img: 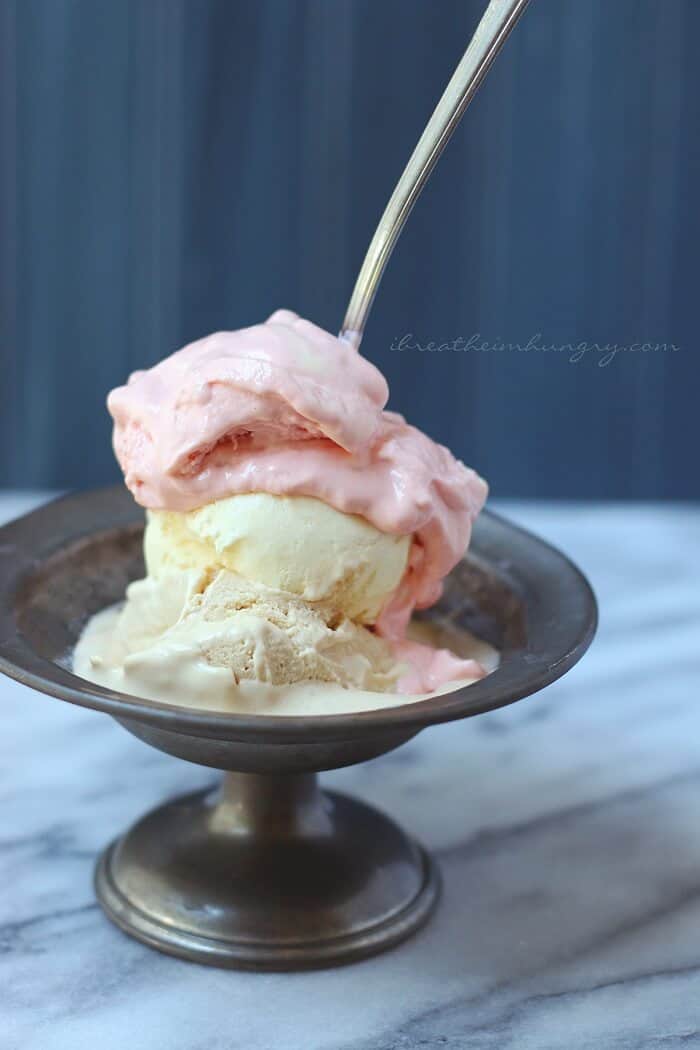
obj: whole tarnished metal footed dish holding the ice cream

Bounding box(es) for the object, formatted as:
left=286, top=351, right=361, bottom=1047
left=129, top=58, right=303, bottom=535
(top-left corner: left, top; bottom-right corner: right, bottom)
left=0, top=486, right=596, bottom=970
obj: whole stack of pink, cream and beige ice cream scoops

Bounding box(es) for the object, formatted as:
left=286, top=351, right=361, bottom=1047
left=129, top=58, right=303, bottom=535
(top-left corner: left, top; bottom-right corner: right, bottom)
left=75, top=310, right=488, bottom=713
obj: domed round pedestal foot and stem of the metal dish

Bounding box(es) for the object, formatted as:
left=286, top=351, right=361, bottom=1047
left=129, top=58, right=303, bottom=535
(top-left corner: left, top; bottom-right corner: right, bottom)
left=96, top=773, right=440, bottom=970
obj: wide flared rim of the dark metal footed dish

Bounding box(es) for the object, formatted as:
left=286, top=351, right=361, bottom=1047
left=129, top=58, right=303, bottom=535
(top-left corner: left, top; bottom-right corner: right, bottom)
left=0, top=485, right=597, bottom=744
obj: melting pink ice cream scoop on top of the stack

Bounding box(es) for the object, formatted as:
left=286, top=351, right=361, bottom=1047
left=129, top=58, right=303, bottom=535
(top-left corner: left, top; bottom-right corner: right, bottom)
left=107, top=310, right=488, bottom=689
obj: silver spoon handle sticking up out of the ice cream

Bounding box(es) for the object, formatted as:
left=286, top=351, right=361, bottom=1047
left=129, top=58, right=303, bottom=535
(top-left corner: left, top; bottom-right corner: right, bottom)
left=340, top=0, right=528, bottom=347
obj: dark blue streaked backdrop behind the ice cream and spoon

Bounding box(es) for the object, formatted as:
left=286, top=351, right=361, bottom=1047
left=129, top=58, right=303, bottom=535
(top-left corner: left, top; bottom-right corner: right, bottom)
left=0, top=0, right=700, bottom=498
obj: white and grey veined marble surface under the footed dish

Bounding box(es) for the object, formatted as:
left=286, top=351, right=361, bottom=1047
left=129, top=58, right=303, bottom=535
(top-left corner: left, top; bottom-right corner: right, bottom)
left=0, top=495, right=700, bottom=1050
